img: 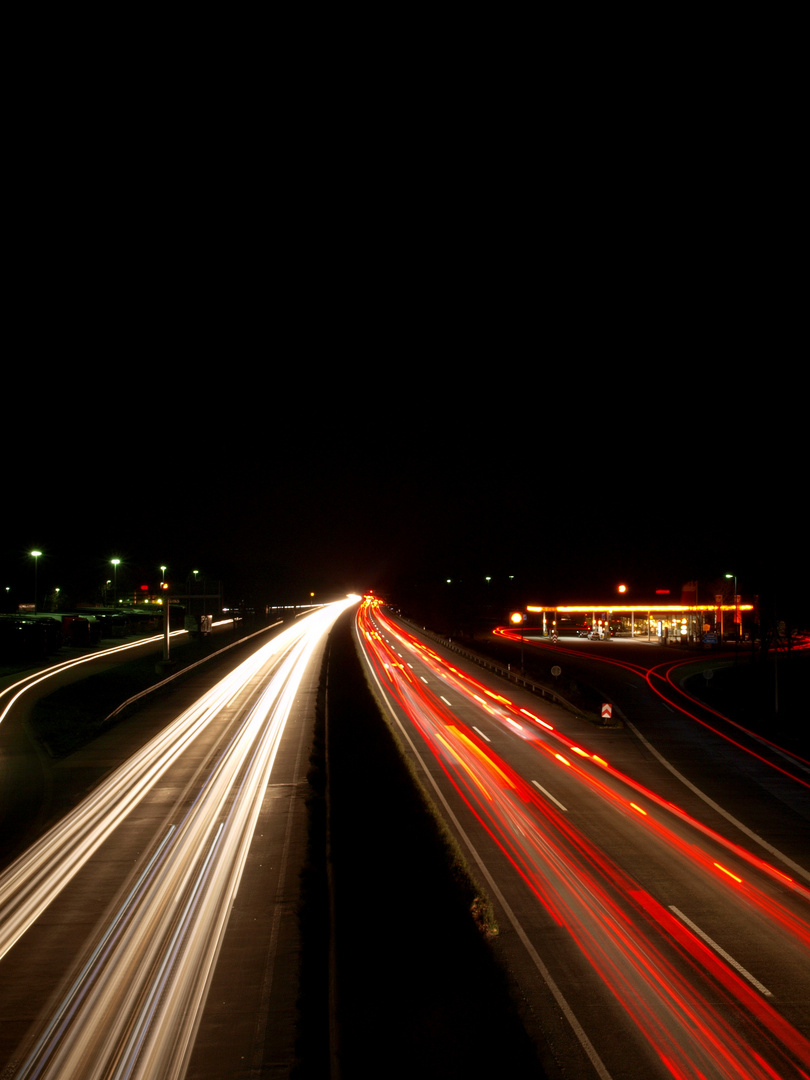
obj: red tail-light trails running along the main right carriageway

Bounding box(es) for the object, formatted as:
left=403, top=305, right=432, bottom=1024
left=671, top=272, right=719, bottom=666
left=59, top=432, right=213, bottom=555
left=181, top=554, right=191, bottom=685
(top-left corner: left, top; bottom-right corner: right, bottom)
left=357, top=603, right=810, bottom=1080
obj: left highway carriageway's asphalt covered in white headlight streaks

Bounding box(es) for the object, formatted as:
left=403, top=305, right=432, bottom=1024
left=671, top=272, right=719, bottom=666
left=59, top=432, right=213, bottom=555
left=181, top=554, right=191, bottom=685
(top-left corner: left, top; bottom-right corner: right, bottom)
left=0, top=599, right=354, bottom=1080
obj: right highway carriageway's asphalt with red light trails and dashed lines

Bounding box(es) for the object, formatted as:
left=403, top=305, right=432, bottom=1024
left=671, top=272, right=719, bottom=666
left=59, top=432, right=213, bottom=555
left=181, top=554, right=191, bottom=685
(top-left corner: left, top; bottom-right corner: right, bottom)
left=356, top=602, right=810, bottom=1080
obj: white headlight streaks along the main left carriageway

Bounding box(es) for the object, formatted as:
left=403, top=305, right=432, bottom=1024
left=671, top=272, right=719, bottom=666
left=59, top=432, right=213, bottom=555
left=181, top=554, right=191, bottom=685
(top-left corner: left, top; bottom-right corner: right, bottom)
left=0, top=600, right=353, bottom=1080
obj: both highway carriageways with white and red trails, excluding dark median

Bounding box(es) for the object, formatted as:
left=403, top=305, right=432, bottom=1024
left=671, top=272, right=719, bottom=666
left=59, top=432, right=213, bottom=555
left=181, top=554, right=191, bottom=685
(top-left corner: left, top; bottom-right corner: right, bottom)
left=6, top=602, right=810, bottom=1080
